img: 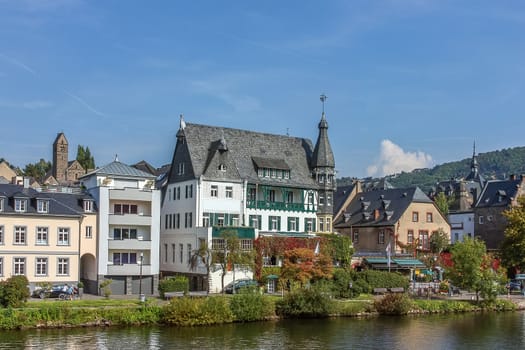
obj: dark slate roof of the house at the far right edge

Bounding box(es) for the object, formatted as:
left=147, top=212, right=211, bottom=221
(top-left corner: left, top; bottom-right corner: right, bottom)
left=476, top=178, right=523, bottom=208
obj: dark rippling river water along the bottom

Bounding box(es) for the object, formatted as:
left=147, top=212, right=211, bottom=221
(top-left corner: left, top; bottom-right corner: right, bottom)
left=0, top=312, right=525, bottom=350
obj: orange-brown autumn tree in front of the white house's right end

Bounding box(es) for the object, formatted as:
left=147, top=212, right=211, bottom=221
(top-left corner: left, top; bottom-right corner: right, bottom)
left=281, top=248, right=332, bottom=286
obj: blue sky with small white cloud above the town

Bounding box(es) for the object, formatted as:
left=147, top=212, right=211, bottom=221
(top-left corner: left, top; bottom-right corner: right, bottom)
left=0, top=0, right=525, bottom=177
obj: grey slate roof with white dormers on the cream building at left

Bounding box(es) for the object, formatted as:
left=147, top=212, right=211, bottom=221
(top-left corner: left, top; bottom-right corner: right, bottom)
left=0, top=184, right=95, bottom=217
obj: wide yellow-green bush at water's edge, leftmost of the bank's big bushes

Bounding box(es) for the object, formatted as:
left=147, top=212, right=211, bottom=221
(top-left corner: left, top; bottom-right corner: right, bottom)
left=163, top=297, right=233, bottom=326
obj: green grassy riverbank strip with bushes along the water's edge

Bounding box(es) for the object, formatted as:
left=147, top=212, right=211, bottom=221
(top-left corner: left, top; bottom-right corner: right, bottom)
left=0, top=291, right=516, bottom=329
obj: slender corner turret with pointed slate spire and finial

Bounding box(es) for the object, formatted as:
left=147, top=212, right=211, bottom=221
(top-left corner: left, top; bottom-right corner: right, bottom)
left=311, top=94, right=336, bottom=232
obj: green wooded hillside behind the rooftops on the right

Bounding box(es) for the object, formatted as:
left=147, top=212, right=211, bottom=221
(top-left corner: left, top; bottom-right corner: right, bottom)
left=337, top=147, right=525, bottom=192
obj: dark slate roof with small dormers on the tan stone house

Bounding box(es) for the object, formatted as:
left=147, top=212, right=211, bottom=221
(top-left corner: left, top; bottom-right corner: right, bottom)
left=334, top=187, right=433, bottom=228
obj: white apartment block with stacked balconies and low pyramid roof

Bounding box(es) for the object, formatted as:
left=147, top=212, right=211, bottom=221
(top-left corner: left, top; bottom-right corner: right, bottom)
left=80, top=160, right=161, bottom=294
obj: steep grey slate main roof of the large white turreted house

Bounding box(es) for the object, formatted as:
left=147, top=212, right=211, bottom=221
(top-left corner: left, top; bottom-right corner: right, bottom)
left=174, top=123, right=318, bottom=188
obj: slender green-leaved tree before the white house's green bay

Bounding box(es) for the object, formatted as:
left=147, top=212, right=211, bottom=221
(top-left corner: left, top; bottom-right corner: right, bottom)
left=213, top=229, right=255, bottom=293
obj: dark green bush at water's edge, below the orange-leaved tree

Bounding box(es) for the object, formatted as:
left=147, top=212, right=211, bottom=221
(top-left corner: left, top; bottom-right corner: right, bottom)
left=275, top=288, right=334, bottom=317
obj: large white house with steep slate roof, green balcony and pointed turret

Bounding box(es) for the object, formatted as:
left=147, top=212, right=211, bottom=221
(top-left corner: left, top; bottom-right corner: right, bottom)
left=160, top=109, right=335, bottom=292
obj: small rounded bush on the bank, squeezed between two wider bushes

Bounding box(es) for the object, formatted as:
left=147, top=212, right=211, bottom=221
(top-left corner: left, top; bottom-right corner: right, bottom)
left=230, top=293, right=274, bottom=322
